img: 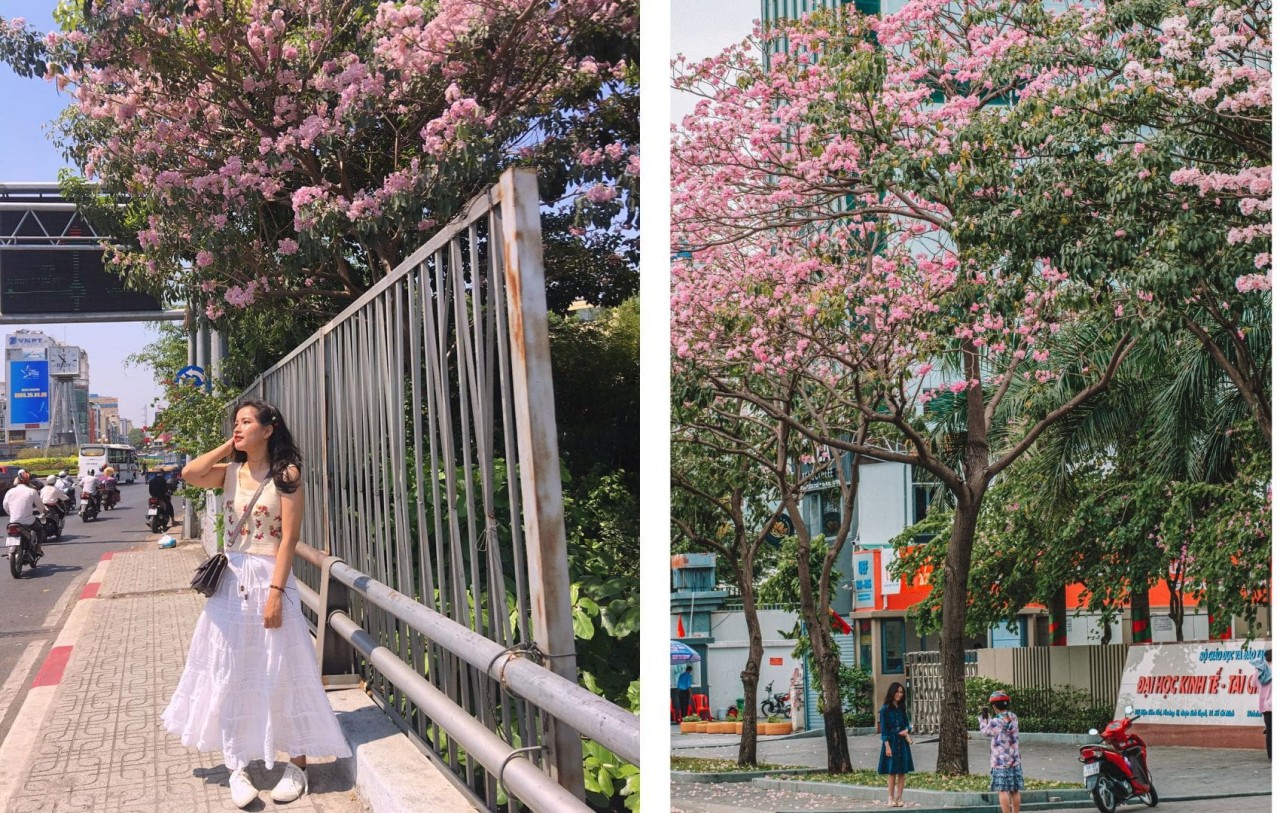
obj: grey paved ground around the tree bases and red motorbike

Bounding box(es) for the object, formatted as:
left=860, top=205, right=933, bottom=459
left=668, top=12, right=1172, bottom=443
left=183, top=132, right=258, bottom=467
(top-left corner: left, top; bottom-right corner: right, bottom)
left=671, top=734, right=1271, bottom=813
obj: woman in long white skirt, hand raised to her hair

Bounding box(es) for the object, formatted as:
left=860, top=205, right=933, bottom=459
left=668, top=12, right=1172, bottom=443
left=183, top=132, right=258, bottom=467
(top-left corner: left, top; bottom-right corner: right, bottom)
left=163, top=401, right=351, bottom=808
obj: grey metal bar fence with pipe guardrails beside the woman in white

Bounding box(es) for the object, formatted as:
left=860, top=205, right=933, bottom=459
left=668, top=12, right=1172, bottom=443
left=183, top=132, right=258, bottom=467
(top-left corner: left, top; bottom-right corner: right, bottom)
left=224, top=170, right=640, bottom=810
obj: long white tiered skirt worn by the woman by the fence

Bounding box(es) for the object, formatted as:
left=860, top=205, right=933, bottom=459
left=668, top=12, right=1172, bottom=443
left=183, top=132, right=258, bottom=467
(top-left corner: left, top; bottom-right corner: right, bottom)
left=161, top=553, right=351, bottom=771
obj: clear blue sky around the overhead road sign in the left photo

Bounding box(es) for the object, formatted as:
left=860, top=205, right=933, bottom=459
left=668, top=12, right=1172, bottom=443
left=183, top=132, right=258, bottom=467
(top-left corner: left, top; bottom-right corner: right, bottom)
left=0, top=0, right=172, bottom=425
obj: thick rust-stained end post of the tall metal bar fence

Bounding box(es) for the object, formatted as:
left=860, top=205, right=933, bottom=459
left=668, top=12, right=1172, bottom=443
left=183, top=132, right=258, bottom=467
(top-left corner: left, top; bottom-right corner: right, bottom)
left=498, top=169, right=585, bottom=799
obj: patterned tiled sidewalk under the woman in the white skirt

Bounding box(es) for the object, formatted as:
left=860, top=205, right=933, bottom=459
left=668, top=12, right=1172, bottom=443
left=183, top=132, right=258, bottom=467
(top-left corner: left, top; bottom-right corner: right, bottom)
left=8, top=544, right=365, bottom=813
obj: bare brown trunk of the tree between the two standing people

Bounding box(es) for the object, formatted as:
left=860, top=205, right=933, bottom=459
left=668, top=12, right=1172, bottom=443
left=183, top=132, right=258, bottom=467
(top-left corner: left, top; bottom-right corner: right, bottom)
left=937, top=499, right=980, bottom=776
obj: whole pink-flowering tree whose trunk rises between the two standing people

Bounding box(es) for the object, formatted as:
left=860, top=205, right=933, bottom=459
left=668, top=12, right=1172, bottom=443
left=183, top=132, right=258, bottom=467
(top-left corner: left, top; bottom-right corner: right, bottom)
left=672, top=0, right=1268, bottom=772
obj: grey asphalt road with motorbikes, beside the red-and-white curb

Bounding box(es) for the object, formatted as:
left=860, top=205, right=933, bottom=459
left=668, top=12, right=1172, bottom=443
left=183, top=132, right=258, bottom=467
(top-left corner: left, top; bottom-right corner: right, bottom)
left=0, top=483, right=183, bottom=740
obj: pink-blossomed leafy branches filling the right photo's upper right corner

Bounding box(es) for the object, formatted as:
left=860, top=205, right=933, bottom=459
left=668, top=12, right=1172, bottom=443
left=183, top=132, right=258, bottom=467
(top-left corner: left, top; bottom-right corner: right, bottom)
left=972, top=0, right=1271, bottom=438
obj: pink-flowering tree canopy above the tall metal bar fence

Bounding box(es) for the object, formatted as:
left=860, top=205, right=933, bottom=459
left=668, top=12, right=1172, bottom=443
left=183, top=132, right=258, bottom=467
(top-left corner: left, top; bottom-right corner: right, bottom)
left=0, top=0, right=639, bottom=320
